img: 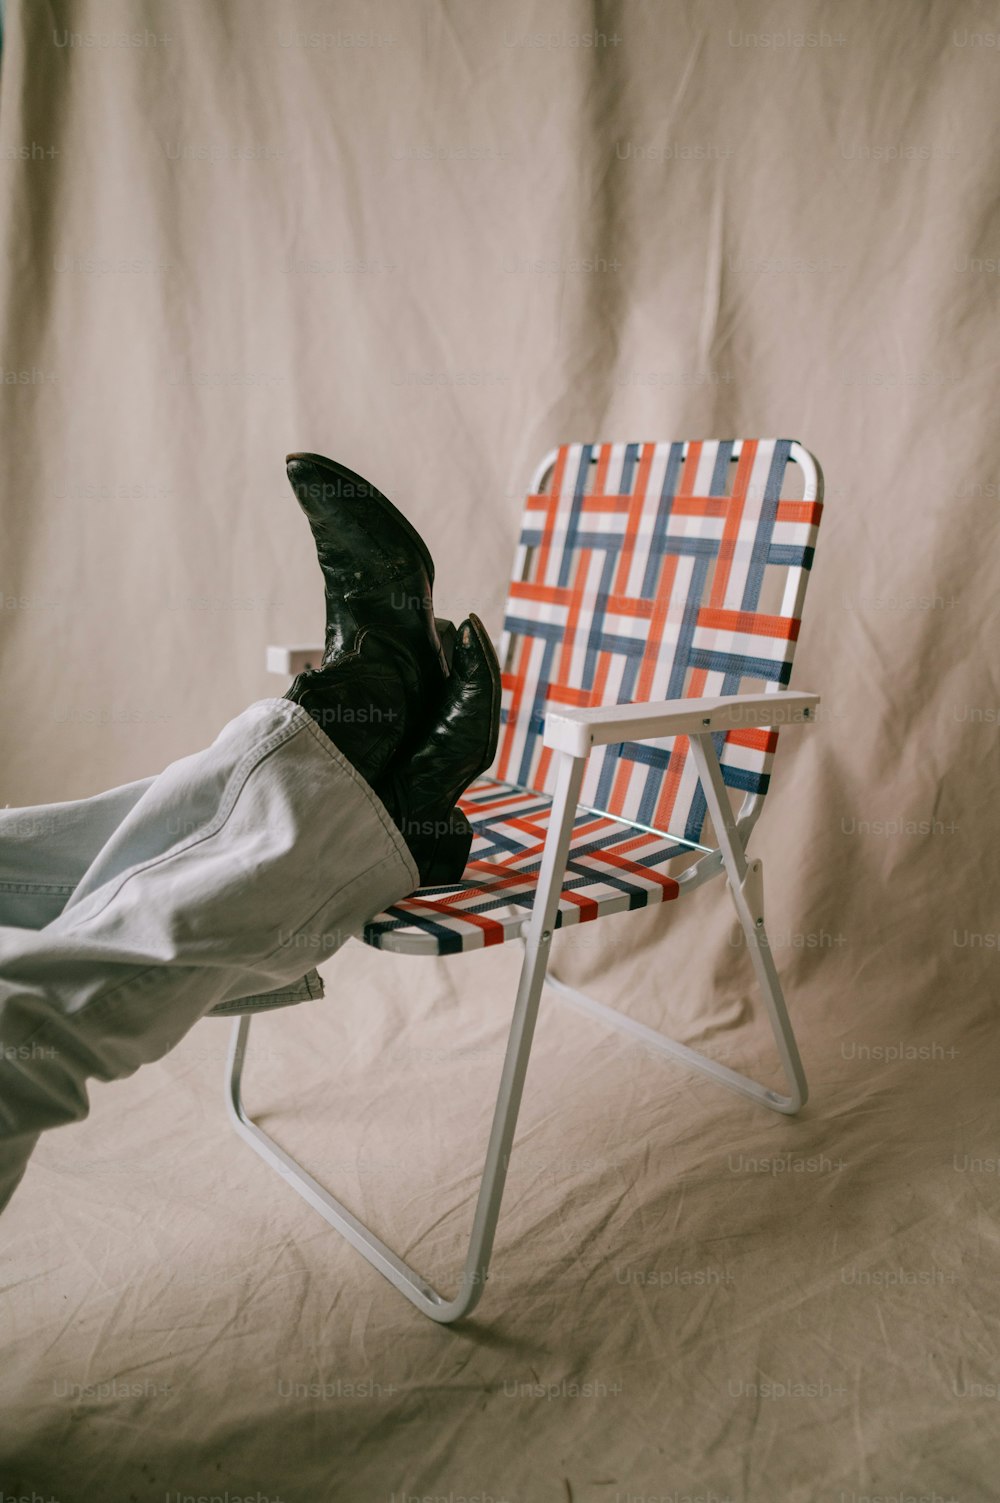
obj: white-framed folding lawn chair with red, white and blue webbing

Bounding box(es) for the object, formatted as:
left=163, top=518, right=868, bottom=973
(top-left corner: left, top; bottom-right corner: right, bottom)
left=222, top=439, right=823, bottom=1323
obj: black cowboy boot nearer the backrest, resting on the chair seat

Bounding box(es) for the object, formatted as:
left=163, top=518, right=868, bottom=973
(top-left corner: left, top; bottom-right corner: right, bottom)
left=373, top=615, right=501, bottom=887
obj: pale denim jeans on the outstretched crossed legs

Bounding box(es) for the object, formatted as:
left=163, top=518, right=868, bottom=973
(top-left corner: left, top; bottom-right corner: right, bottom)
left=0, top=699, right=420, bottom=1208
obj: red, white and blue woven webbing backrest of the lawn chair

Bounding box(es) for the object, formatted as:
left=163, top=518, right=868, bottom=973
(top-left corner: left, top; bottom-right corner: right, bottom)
left=495, top=439, right=823, bottom=842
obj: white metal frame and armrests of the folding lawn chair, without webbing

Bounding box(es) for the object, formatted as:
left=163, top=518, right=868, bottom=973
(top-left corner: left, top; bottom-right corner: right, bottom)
left=227, top=443, right=823, bottom=1324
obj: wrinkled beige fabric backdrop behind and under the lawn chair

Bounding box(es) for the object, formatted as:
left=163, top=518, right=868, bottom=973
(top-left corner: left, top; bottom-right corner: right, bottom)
left=0, top=0, right=1000, bottom=1503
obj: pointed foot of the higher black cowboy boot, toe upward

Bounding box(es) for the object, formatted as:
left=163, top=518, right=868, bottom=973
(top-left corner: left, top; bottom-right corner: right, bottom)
left=286, top=454, right=454, bottom=745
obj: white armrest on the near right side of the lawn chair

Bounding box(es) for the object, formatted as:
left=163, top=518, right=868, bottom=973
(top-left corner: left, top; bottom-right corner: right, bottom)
left=543, top=691, right=820, bottom=756
